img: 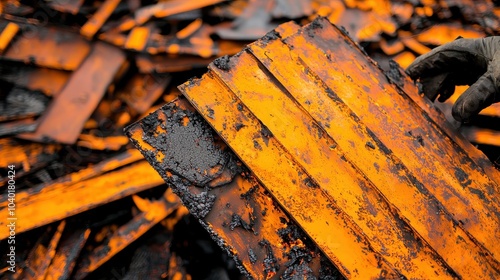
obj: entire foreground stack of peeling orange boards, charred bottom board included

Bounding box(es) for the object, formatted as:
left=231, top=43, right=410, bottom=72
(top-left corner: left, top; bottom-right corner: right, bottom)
left=128, top=18, right=500, bottom=279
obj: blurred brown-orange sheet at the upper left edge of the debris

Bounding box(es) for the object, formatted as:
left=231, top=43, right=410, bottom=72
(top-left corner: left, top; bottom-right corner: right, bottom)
left=0, top=24, right=91, bottom=71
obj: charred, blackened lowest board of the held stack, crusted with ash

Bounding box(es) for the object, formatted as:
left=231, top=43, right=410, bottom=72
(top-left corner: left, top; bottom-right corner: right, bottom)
left=126, top=99, right=344, bottom=279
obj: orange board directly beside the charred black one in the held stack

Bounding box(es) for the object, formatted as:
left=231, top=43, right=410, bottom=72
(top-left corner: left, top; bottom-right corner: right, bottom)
left=180, top=72, right=398, bottom=279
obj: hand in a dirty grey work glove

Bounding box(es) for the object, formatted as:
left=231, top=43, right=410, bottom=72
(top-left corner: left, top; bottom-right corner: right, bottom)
left=406, top=36, right=500, bottom=121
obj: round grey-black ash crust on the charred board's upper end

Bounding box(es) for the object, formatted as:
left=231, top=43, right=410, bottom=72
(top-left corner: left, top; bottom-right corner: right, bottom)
left=141, top=104, right=229, bottom=186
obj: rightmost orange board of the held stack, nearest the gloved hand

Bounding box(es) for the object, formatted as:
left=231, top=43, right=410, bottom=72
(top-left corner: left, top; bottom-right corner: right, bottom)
left=285, top=18, right=500, bottom=260
